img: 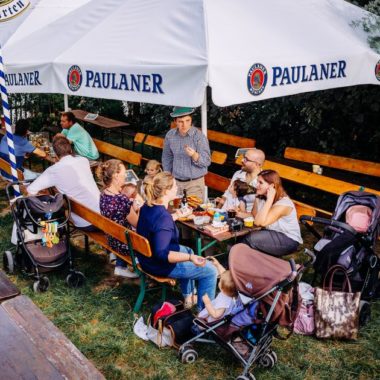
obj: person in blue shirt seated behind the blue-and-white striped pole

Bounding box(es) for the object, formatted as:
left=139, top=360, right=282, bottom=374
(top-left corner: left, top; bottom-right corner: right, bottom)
left=0, top=119, right=46, bottom=180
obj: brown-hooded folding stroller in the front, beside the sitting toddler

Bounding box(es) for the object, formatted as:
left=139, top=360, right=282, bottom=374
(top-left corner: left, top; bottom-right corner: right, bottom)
left=179, top=244, right=314, bottom=380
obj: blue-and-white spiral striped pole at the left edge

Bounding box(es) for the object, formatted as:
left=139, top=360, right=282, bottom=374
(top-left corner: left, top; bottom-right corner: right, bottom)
left=0, top=46, right=20, bottom=197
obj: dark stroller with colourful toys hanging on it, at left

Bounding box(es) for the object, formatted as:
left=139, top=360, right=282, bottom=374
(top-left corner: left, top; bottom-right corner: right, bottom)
left=3, top=181, right=85, bottom=292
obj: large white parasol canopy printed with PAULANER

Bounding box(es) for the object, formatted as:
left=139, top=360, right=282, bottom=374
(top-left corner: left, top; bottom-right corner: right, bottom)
left=4, top=0, right=380, bottom=106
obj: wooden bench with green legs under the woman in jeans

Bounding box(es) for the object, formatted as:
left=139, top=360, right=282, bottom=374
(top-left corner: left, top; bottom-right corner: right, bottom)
left=70, top=199, right=176, bottom=313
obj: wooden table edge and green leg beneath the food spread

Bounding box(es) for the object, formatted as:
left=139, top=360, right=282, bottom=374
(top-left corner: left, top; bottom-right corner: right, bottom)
left=177, top=220, right=257, bottom=256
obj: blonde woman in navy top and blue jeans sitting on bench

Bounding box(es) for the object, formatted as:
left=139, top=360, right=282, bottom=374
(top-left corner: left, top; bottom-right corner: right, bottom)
left=137, top=172, right=217, bottom=310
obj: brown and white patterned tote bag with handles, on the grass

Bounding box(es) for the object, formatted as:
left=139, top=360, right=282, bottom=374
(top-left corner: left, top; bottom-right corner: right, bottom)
left=314, top=265, right=360, bottom=339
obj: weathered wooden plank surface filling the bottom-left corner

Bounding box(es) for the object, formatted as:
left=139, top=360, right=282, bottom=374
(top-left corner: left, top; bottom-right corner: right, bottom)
left=0, top=296, right=105, bottom=380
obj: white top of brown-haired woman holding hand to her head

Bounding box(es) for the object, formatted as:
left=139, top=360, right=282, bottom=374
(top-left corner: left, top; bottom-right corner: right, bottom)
left=257, top=197, right=302, bottom=244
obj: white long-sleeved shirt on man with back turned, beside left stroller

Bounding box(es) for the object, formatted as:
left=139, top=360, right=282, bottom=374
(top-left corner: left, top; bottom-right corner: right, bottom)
left=27, top=155, right=100, bottom=227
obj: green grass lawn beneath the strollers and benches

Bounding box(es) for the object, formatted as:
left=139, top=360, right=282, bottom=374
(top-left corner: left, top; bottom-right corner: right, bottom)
left=0, top=192, right=380, bottom=380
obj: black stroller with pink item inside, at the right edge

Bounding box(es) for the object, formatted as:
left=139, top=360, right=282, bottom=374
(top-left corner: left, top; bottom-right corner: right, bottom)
left=300, top=191, right=380, bottom=325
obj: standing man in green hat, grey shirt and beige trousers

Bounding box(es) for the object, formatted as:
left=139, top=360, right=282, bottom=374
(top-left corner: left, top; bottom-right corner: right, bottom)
left=162, top=107, right=211, bottom=200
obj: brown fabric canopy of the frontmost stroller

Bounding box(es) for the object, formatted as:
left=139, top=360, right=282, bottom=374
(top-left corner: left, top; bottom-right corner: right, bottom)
left=229, top=244, right=292, bottom=298
